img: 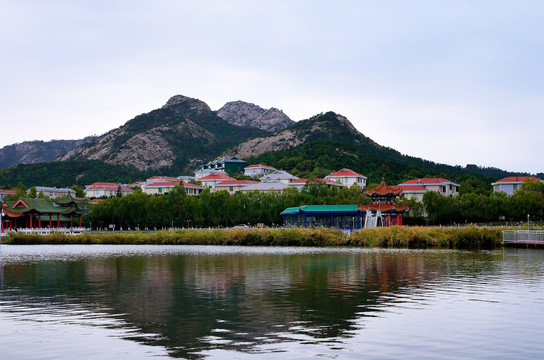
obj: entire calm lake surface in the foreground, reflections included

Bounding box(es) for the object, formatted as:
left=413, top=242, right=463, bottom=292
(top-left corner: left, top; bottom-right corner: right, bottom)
left=0, top=245, right=544, bottom=360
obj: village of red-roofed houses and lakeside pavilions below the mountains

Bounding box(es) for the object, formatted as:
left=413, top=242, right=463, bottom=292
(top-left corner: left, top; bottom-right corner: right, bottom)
left=0, top=157, right=544, bottom=235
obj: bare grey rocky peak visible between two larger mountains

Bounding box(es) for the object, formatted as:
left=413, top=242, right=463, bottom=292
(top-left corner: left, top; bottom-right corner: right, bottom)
left=216, top=101, right=295, bottom=132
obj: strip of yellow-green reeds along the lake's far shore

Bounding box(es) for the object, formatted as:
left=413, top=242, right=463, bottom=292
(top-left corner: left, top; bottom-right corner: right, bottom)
left=0, top=226, right=502, bottom=249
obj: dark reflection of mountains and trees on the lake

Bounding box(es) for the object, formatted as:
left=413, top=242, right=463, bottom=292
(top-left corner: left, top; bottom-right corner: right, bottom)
left=2, top=250, right=504, bottom=357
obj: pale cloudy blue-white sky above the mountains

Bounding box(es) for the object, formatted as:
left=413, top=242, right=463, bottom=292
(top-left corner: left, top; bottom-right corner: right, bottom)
left=0, top=0, right=544, bottom=174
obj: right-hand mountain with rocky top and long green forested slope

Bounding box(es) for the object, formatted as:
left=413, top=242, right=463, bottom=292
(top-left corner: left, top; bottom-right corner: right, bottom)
left=223, top=112, right=511, bottom=182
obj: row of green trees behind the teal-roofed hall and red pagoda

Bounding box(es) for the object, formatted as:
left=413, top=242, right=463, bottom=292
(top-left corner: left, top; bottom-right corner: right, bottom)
left=87, top=181, right=544, bottom=228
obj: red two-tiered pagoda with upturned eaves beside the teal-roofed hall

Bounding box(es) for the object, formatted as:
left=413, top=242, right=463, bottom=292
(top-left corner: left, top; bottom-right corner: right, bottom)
left=359, top=178, right=408, bottom=227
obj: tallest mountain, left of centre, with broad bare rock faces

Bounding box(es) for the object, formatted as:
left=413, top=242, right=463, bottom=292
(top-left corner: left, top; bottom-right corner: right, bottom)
left=60, top=95, right=263, bottom=172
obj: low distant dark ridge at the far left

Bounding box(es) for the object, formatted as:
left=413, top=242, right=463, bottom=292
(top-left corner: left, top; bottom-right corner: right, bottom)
left=0, top=136, right=95, bottom=169
